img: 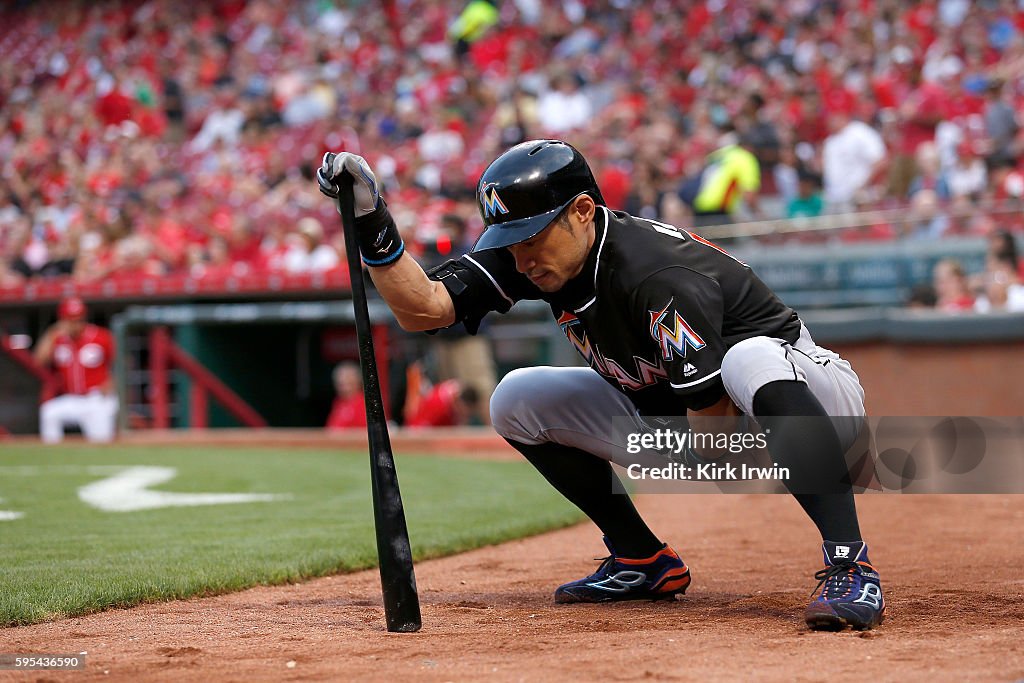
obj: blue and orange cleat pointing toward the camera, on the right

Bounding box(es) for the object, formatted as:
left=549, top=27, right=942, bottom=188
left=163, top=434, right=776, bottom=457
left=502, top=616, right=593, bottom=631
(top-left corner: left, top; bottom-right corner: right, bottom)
left=804, top=541, right=886, bottom=631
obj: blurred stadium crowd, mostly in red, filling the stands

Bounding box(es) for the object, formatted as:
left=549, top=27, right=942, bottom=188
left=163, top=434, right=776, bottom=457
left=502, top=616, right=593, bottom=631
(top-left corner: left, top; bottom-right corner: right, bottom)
left=0, top=0, right=1024, bottom=307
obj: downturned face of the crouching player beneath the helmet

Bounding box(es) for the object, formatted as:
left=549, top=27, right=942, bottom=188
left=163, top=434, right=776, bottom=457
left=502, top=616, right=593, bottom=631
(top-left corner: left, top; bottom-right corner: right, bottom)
left=508, top=195, right=596, bottom=292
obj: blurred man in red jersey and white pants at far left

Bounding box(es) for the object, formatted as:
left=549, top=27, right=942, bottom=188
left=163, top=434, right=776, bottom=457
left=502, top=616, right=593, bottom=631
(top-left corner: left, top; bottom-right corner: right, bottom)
left=34, top=297, right=118, bottom=443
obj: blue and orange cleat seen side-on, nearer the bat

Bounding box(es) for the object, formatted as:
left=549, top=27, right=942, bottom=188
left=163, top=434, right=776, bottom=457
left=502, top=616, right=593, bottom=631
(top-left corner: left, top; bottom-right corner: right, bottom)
left=555, top=539, right=690, bottom=603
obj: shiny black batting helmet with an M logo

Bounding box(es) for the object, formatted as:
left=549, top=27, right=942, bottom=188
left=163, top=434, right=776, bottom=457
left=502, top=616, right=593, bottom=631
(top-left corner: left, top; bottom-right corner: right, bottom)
left=473, top=140, right=604, bottom=251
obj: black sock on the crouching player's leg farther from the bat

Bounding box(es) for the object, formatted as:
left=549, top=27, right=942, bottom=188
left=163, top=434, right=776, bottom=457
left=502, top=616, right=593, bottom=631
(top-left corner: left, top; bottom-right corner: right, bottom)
left=754, top=380, right=861, bottom=541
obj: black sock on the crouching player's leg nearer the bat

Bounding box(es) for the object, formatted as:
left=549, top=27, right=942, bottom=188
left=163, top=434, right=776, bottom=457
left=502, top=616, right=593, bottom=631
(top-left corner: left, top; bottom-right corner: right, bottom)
left=505, top=439, right=664, bottom=558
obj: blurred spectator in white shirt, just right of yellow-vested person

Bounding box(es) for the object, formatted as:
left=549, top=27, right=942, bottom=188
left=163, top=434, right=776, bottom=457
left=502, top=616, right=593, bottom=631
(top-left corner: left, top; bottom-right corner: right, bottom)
left=821, top=112, right=886, bottom=213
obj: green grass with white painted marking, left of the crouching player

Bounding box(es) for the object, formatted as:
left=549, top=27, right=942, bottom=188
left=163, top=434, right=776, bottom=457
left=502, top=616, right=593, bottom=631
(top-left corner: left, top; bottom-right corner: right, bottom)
left=0, top=445, right=581, bottom=626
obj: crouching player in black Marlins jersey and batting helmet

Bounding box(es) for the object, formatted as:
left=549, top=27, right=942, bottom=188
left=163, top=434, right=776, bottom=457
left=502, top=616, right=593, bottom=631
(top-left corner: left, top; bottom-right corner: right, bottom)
left=317, top=140, right=885, bottom=630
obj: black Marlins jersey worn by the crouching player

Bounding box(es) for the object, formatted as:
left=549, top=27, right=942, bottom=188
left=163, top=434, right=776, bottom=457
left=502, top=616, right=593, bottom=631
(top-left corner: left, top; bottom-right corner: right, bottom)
left=431, top=207, right=800, bottom=415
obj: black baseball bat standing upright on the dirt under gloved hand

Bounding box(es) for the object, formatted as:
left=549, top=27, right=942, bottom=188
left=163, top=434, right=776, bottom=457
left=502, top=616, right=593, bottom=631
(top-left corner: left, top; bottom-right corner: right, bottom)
left=338, top=171, right=421, bottom=633
